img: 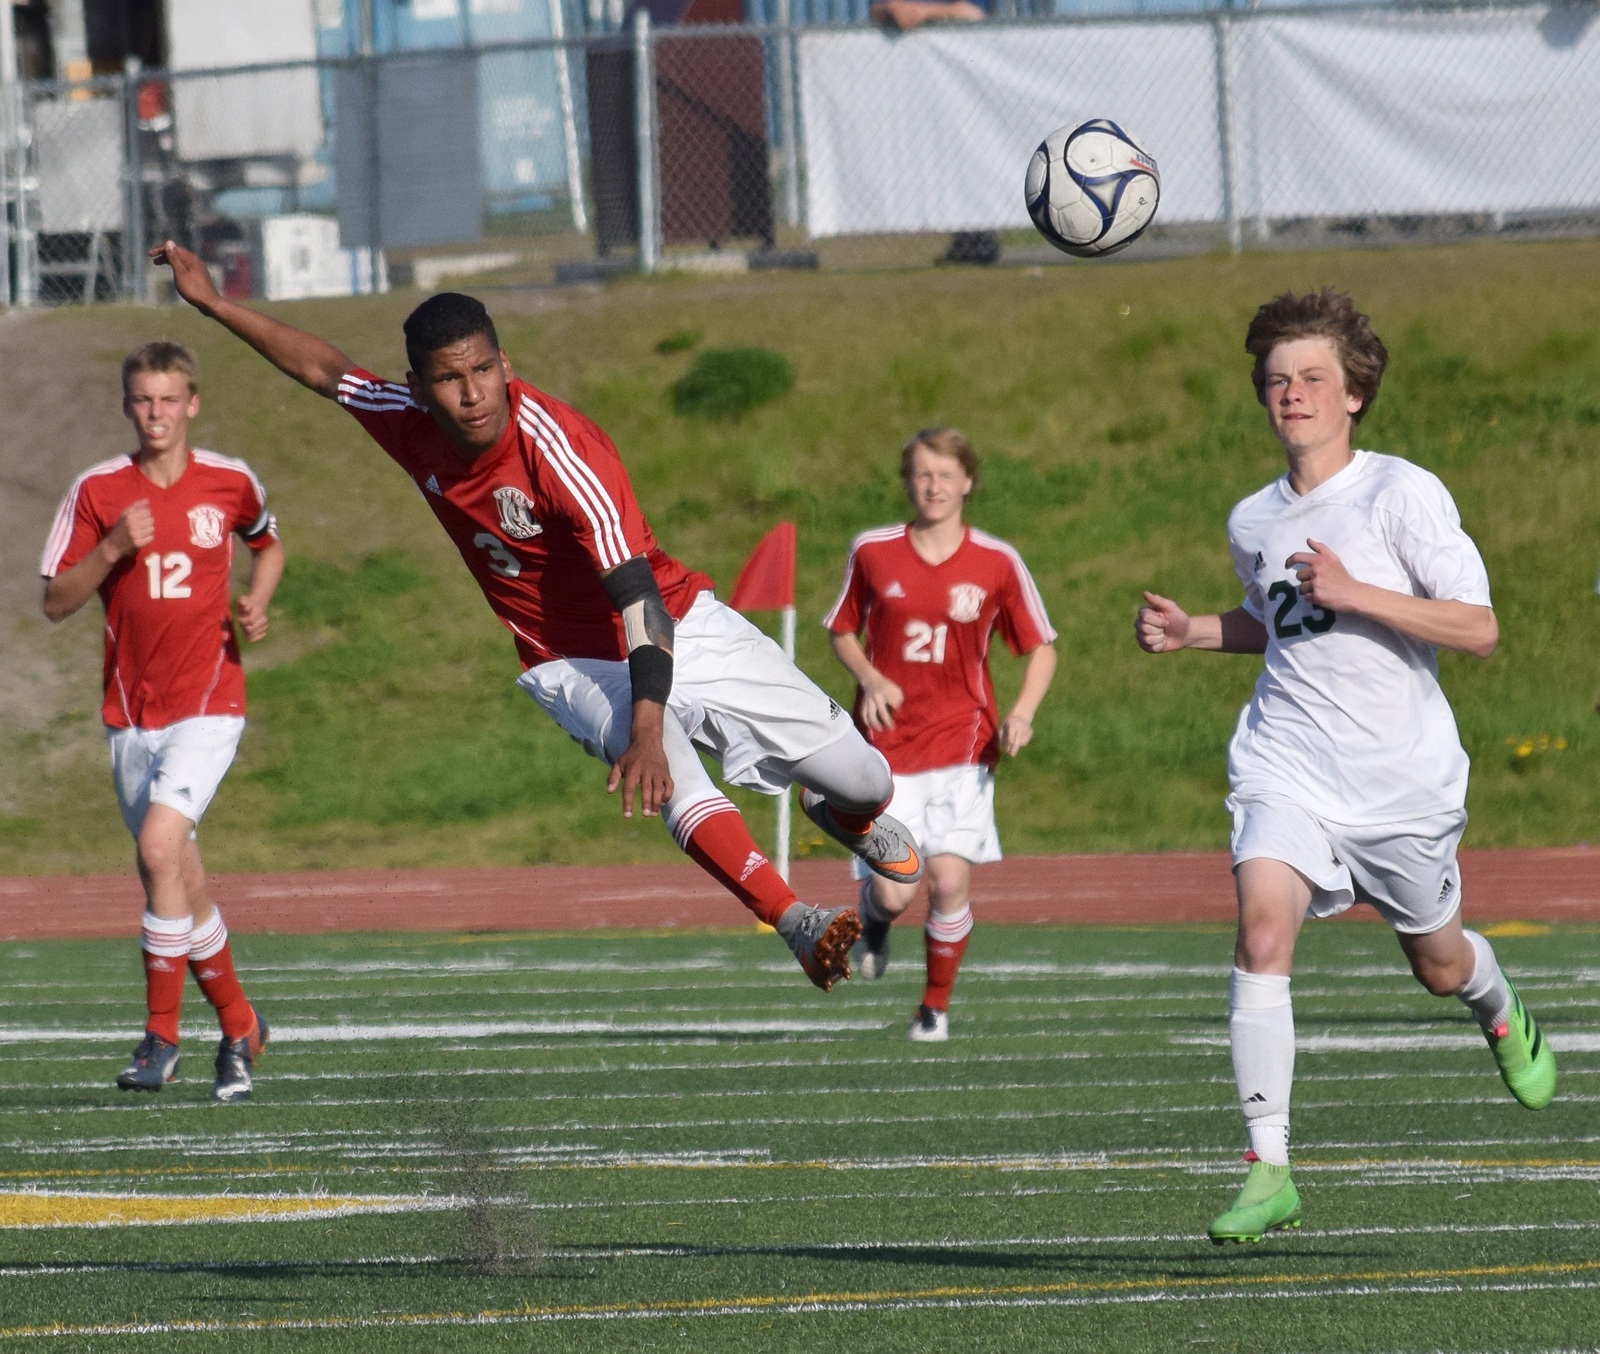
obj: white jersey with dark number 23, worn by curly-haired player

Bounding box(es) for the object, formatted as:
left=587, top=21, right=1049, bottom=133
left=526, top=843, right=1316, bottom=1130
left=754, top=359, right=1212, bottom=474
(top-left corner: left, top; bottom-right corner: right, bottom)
left=1227, top=451, right=1490, bottom=826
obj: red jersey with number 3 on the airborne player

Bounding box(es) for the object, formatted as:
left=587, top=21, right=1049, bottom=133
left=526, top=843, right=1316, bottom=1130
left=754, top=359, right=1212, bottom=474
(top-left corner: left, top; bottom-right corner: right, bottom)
left=339, top=370, right=714, bottom=667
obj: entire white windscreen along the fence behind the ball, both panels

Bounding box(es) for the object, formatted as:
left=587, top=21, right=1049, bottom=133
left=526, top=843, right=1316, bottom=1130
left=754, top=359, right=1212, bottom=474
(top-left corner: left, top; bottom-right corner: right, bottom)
left=800, top=6, right=1600, bottom=237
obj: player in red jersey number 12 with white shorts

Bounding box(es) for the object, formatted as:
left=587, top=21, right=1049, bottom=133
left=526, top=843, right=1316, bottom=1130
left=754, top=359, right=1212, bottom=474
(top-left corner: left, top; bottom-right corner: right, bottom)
left=40, top=343, right=283, bottom=1101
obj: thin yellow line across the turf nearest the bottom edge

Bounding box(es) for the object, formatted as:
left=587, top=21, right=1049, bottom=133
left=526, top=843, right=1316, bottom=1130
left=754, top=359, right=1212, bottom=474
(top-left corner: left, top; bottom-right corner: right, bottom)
left=0, top=1260, right=1600, bottom=1340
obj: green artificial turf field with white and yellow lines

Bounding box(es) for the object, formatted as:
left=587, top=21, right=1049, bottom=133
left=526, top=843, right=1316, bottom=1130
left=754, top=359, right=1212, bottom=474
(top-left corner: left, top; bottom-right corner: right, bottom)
left=0, top=922, right=1600, bottom=1354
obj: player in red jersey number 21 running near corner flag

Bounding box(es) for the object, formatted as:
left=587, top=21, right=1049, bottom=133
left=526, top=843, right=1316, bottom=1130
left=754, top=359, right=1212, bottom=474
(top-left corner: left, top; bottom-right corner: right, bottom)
left=824, top=427, right=1056, bottom=1042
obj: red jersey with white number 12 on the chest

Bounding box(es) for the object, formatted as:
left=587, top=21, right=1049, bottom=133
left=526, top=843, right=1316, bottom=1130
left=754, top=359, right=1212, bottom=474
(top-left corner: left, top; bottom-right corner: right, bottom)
left=38, top=448, right=278, bottom=728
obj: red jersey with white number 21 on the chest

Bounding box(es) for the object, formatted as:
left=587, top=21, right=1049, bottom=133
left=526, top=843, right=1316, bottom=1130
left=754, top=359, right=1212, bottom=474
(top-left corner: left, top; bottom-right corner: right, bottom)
left=822, top=527, right=1056, bottom=776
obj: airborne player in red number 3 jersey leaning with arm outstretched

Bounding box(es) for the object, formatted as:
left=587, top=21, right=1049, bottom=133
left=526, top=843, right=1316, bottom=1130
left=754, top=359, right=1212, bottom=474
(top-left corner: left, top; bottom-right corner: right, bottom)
left=154, top=243, right=922, bottom=991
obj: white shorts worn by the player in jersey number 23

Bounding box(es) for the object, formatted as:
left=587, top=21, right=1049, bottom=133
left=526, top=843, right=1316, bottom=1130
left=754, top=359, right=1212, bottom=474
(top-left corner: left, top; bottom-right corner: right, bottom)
left=1227, top=795, right=1467, bottom=936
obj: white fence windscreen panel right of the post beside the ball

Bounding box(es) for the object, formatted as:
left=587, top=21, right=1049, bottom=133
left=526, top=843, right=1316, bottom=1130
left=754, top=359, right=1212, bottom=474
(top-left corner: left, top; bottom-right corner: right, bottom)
left=1228, top=5, right=1600, bottom=218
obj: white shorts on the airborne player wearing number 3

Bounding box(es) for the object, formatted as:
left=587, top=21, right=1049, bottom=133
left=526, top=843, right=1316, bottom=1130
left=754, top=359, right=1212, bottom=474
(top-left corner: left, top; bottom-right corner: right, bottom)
left=517, top=592, right=853, bottom=802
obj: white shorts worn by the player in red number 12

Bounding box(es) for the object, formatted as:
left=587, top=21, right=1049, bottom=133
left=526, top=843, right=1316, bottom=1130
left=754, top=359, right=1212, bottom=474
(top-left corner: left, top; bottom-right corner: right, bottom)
left=106, top=715, right=245, bottom=837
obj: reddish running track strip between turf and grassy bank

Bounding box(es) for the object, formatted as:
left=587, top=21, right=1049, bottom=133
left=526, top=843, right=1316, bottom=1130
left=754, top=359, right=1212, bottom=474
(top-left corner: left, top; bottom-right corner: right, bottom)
left=0, top=848, right=1600, bottom=939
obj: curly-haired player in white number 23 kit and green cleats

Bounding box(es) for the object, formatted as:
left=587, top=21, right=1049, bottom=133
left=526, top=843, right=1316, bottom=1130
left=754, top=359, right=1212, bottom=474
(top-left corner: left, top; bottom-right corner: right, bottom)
left=1136, top=290, right=1555, bottom=1244
